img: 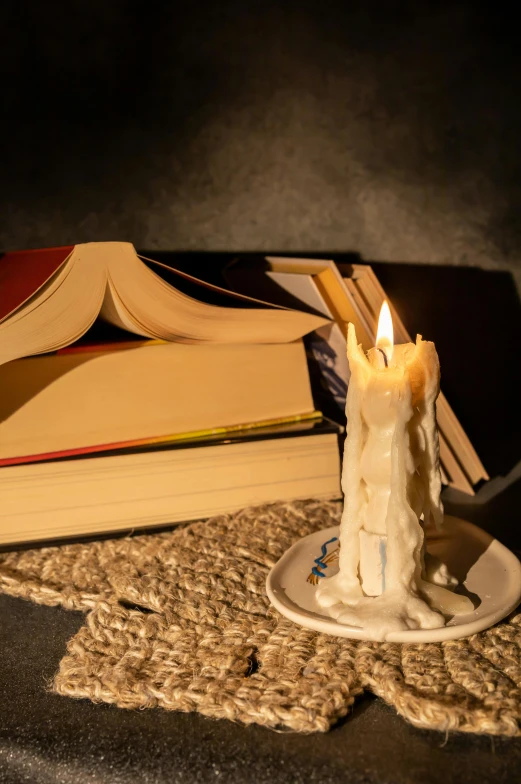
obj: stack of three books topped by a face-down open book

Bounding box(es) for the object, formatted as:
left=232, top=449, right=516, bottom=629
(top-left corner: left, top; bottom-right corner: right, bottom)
left=0, top=243, right=340, bottom=545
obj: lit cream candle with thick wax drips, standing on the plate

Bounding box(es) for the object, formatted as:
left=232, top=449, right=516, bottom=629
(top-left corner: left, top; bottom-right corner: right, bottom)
left=316, top=303, right=473, bottom=640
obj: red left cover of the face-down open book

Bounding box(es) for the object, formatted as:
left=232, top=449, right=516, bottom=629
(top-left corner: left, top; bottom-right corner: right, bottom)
left=0, top=245, right=74, bottom=322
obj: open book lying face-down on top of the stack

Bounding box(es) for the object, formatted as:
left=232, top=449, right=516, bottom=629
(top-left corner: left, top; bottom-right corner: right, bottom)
left=0, top=242, right=326, bottom=364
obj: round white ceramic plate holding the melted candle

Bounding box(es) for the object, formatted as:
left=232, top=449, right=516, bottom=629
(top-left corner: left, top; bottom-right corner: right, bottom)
left=266, top=516, right=521, bottom=642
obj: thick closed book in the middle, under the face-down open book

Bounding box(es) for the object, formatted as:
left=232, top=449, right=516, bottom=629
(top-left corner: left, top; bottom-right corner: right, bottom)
left=0, top=340, right=316, bottom=470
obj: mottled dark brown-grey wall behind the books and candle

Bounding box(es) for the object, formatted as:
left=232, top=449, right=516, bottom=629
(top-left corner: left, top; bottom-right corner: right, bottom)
left=0, top=0, right=521, bottom=282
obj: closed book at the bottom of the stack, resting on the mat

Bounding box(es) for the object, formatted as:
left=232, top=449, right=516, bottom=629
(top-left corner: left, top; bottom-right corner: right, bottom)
left=0, top=420, right=340, bottom=547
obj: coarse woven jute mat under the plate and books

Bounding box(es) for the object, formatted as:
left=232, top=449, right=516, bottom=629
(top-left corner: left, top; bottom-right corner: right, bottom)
left=0, top=501, right=521, bottom=735
